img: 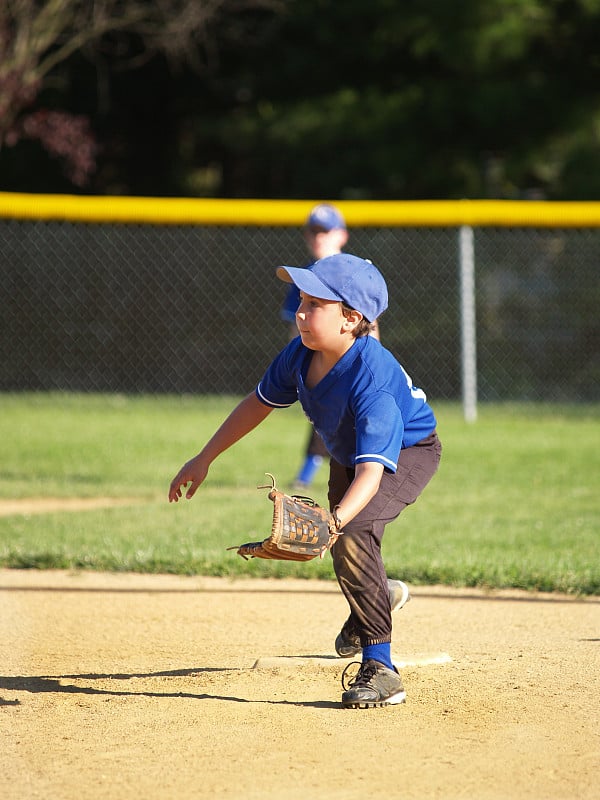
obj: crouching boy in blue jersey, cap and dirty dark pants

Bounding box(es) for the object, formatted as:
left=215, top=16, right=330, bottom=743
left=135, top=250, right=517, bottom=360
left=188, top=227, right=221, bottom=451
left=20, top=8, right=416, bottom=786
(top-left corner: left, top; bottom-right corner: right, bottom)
left=169, top=253, right=441, bottom=708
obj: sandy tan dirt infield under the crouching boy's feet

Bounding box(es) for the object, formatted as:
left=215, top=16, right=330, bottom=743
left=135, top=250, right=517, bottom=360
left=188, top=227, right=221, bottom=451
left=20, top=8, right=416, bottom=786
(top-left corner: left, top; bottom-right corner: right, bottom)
left=0, top=570, right=600, bottom=800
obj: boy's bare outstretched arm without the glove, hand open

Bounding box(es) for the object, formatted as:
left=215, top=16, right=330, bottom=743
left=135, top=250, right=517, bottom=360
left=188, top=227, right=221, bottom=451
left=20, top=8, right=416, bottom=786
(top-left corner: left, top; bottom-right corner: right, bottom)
left=169, top=392, right=273, bottom=503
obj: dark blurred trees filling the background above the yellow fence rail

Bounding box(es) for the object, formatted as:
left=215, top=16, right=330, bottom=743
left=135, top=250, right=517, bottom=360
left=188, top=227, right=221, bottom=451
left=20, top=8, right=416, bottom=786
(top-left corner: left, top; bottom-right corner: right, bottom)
left=0, top=0, right=600, bottom=199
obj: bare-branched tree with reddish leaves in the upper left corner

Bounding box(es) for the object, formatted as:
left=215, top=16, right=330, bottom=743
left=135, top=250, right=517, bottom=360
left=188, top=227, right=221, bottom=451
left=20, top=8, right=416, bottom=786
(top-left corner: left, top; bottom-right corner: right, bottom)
left=0, top=0, right=279, bottom=186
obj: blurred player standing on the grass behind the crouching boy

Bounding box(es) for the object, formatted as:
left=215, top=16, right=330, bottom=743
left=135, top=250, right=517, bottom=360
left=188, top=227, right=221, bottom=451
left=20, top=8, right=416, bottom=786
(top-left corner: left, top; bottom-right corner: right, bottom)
left=281, top=203, right=379, bottom=492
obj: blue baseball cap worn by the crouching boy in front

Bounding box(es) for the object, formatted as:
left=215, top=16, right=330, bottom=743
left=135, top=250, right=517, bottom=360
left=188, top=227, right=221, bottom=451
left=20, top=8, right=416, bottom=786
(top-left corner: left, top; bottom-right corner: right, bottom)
left=276, top=253, right=388, bottom=322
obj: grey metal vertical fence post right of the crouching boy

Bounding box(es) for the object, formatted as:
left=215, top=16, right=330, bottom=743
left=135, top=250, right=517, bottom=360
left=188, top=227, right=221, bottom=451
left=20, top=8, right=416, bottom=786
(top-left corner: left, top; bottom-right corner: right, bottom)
left=458, top=225, right=477, bottom=422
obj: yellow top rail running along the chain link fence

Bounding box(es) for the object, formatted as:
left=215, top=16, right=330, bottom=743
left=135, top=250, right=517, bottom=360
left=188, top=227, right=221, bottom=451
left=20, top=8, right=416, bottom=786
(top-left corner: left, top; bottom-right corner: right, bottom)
left=0, top=192, right=600, bottom=228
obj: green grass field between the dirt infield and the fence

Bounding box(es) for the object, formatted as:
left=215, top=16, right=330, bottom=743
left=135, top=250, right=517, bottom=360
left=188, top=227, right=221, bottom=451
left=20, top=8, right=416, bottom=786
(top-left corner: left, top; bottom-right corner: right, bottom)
left=0, top=393, right=600, bottom=594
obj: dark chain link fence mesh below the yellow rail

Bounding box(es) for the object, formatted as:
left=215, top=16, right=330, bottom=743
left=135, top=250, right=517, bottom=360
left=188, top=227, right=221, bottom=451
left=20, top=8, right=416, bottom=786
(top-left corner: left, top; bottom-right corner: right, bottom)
left=0, top=212, right=600, bottom=402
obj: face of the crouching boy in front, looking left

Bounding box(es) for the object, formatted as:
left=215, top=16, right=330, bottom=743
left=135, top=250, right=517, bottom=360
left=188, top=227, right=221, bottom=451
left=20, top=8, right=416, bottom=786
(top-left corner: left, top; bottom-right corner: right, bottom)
left=296, top=292, right=361, bottom=351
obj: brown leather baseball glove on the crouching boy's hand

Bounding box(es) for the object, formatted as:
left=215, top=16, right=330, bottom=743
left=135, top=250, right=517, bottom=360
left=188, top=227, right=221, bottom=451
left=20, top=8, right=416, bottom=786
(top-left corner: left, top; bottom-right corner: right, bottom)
left=227, top=472, right=340, bottom=561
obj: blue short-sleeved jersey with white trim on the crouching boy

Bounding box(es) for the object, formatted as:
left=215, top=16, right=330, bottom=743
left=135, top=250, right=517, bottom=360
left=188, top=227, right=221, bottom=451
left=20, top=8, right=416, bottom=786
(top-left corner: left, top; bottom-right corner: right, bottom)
left=256, top=336, right=436, bottom=472
